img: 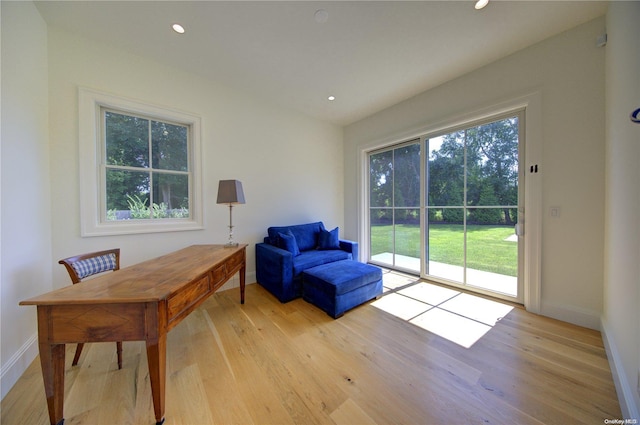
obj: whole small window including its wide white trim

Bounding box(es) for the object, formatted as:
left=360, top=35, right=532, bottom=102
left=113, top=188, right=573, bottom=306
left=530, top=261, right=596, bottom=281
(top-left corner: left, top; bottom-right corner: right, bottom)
left=80, top=89, right=202, bottom=236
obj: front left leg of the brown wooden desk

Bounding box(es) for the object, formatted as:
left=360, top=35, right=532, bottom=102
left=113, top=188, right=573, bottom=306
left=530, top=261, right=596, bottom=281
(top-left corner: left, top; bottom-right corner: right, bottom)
left=38, top=306, right=65, bottom=425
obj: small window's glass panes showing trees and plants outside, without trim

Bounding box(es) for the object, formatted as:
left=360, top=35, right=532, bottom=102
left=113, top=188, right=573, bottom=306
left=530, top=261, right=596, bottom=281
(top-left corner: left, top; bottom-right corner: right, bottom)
left=103, top=109, right=190, bottom=221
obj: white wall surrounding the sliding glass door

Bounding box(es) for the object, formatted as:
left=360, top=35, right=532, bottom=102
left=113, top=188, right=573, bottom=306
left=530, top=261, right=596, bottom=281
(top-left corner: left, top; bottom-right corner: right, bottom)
left=345, top=17, right=605, bottom=328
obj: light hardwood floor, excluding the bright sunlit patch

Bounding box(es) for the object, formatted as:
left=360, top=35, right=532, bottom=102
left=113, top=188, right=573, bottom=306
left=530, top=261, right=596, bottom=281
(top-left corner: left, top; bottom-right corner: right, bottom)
left=1, top=272, right=621, bottom=425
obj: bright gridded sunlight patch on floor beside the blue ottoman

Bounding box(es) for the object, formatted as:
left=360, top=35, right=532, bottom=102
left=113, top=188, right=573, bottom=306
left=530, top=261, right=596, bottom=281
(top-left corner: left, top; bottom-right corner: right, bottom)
left=371, top=272, right=513, bottom=348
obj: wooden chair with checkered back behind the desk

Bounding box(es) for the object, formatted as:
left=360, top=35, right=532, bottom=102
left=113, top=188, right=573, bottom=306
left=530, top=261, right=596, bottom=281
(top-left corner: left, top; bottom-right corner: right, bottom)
left=58, top=248, right=122, bottom=369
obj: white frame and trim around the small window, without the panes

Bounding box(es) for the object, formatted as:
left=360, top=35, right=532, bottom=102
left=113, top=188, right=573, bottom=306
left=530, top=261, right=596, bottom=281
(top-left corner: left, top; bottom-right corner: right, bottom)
left=78, top=87, right=204, bottom=237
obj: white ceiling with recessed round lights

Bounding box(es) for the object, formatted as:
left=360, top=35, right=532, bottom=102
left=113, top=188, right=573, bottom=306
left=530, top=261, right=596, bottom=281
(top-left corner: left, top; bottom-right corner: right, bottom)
left=36, top=0, right=606, bottom=125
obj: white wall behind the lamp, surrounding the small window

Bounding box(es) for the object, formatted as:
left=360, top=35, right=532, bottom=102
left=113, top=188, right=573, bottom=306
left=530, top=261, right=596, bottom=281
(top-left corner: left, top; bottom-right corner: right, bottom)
left=49, top=28, right=343, bottom=286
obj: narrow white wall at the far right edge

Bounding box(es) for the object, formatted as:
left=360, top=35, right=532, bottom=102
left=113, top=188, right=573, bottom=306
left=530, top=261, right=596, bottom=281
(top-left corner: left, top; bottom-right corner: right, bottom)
left=602, top=2, right=640, bottom=419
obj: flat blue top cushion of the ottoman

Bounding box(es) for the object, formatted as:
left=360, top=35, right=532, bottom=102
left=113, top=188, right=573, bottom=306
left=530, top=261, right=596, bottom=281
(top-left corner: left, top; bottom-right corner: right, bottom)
left=304, top=258, right=382, bottom=296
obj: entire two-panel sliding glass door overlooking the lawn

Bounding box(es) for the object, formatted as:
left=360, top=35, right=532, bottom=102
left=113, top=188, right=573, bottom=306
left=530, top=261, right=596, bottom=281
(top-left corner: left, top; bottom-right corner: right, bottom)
left=369, top=113, right=524, bottom=301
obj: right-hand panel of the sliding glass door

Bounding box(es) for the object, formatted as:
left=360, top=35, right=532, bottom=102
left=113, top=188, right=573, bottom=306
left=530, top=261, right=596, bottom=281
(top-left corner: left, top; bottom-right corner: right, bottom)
left=425, top=115, right=520, bottom=297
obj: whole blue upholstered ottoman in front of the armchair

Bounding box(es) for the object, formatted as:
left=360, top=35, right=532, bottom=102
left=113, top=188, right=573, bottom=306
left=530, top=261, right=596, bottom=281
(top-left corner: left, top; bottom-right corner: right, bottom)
left=302, top=260, right=382, bottom=319
